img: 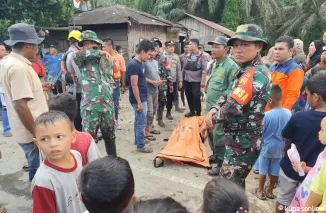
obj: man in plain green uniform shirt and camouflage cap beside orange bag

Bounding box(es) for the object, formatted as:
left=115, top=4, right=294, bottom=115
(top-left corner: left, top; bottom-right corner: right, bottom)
left=206, top=36, right=239, bottom=176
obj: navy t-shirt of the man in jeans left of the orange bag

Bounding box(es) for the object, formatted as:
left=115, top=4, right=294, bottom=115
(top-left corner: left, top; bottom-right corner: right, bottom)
left=127, top=58, right=147, bottom=104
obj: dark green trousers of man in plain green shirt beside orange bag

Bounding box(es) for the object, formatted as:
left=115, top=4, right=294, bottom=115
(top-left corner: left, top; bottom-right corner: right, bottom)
left=207, top=123, right=225, bottom=166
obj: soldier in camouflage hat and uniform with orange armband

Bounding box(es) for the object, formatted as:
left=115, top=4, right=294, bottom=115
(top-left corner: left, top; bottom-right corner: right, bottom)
left=201, top=24, right=271, bottom=187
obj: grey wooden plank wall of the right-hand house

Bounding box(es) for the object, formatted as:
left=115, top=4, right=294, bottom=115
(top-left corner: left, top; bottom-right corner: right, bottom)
left=178, top=16, right=224, bottom=51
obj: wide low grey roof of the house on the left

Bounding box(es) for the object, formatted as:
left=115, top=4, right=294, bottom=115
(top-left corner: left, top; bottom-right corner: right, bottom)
left=75, top=5, right=181, bottom=27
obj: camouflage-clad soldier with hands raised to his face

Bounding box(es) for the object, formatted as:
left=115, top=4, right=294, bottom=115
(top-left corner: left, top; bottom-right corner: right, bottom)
left=75, top=30, right=116, bottom=155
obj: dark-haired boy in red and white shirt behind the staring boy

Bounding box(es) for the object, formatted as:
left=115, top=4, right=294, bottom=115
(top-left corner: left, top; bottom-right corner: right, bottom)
left=49, top=93, right=101, bottom=166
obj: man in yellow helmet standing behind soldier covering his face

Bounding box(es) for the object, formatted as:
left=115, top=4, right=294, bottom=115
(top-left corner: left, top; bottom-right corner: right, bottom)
left=62, top=30, right=83, bottom=131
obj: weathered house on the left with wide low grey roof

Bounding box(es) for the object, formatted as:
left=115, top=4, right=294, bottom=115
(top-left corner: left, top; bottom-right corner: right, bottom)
left=73, top=5, right=183, bottom=59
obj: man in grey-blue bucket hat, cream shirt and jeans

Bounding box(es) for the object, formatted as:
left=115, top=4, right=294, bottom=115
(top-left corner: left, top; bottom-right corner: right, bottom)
left=0, top=23, right=51, bottom=181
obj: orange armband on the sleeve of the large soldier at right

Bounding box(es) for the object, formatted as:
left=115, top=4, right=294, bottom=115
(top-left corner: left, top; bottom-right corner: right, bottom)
left=231, top=69, right=255, bottom=105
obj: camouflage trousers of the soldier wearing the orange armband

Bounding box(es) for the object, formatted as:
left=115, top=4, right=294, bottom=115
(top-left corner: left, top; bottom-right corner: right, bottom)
left=220, top=133, right=261, bottom=188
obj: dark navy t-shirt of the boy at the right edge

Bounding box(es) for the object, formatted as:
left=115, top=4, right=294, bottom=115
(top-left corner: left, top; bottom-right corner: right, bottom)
left=281, top=110, right=326, bottom=182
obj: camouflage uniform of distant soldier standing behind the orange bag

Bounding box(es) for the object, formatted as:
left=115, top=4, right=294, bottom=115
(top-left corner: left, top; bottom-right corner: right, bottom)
left=156, top=52, right=172, bottom=127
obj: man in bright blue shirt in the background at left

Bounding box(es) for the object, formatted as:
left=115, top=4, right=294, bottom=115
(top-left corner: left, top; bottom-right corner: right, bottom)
left=43, top=44, right=63, bottom=95
